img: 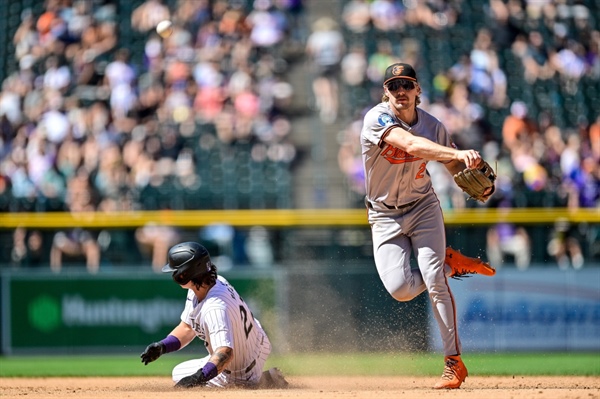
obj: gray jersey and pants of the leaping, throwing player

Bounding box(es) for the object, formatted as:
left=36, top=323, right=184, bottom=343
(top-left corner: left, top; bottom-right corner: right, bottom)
left=361, top=102, right=461, bottom=356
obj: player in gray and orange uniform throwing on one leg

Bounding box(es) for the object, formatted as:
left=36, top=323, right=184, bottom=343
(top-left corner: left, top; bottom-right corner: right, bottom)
left=361, top=63, right=495, bottom=389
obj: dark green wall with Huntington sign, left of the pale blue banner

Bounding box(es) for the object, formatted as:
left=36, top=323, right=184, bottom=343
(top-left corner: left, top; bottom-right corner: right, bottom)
left=1, top=263, right=428, bottom=354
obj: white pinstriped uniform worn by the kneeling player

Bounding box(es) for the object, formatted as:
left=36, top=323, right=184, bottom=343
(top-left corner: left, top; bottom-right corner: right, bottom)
left=173, top=276, right=271, bottom=387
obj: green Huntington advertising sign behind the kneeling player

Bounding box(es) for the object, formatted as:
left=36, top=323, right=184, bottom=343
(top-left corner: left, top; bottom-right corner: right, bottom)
left=2, top=274, right=274, bottom=353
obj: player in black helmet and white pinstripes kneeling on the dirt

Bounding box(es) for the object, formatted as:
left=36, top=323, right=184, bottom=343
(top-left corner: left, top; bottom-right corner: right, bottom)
left=141, top=242, right=287, bottom=388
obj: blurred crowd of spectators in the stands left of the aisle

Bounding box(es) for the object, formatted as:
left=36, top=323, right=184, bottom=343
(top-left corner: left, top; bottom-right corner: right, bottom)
left=0, top=0, right=303, bottom=271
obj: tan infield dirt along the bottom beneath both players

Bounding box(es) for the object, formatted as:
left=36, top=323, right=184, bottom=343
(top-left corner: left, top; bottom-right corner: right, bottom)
left=0, top=376, right=600, bottom=399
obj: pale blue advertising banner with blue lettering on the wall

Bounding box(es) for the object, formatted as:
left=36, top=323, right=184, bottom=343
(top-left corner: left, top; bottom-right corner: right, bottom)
left=429, top=268, right=600, bottom=352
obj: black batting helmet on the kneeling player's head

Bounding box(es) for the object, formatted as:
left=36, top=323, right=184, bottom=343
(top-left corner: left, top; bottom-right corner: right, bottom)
left=162, top=241, right=212, bottom=285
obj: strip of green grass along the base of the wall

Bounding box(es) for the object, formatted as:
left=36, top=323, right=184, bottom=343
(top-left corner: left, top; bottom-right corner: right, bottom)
left=0, top=353, right=600, bottom=377
